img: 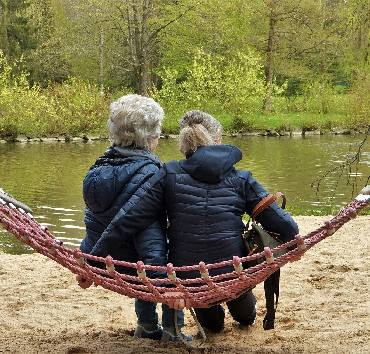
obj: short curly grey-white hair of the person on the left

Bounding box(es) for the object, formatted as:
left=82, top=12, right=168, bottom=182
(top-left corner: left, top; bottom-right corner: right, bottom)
left=107, top=94, right=164, bottom=150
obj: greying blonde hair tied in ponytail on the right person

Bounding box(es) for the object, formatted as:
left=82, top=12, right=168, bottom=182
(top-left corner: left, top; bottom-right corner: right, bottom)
left=179, top=111, right=222, bottom=154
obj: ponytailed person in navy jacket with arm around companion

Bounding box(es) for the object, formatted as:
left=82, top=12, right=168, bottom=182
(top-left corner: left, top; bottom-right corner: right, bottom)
left=91, top=111, right=298, bottom=331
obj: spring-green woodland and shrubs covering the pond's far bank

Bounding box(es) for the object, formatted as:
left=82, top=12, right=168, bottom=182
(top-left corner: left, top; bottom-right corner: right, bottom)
left=0, top=0, right=370, bottom=139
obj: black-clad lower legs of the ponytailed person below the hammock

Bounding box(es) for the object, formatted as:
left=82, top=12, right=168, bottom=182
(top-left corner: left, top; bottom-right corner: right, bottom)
left=194, top=291, right=257, bottom=332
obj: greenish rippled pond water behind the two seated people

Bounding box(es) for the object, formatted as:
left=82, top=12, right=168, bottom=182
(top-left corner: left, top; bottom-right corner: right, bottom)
left=0, top=134, right=370, bottom=254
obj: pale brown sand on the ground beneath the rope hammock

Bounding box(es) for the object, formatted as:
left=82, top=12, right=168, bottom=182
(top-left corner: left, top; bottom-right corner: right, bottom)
left=0, top=216, right=370, bottom=354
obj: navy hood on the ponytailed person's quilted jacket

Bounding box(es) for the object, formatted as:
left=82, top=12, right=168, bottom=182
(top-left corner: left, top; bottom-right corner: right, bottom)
left=179, top=145, right=243, bottom=183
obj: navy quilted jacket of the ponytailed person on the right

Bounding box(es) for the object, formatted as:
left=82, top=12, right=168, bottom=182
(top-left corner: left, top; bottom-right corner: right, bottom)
left=93, top=145, right=298, bottom=277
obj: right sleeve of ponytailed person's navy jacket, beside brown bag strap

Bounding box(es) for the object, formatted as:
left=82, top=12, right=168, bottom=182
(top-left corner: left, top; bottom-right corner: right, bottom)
left=241, top=171, right=299, bottom=242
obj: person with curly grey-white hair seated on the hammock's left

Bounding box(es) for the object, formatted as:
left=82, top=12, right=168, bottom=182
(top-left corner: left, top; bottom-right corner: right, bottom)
left=77, top=95, right=192, bottom=341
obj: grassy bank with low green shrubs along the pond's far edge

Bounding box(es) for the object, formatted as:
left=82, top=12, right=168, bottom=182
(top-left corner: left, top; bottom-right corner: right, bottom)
left=0, top=56, right=370, bottom=140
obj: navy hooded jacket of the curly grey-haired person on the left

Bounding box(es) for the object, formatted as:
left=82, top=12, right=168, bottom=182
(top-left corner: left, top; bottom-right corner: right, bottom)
left=80, top=146, right=167, bottom=277
